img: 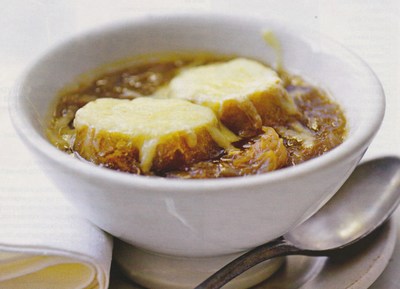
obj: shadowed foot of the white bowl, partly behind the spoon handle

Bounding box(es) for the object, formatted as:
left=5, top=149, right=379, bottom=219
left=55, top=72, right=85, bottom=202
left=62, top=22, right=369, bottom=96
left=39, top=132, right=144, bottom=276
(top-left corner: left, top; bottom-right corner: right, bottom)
left=114, top=241, right=285, bottom=289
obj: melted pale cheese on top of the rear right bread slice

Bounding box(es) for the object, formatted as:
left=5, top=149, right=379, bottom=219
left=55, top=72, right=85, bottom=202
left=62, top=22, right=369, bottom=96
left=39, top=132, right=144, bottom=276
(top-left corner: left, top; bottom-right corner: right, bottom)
left=167, top=58, right=296, bottom=111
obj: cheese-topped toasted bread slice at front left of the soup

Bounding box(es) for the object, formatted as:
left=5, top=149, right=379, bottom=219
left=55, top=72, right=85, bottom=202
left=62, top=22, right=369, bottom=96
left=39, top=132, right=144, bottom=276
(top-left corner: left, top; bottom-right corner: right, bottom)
left=74, top=97, right=238, bottom=173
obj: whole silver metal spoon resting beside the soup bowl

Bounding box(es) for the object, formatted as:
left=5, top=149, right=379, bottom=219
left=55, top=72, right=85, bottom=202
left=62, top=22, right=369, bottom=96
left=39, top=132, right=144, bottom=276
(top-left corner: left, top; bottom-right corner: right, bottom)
left=195, top=157, right=400, bottom=289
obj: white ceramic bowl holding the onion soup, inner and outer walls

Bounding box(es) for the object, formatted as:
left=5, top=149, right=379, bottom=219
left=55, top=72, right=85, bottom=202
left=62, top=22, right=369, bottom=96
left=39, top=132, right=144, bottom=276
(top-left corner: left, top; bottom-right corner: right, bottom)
left=10, top=15, right=384, bottom=256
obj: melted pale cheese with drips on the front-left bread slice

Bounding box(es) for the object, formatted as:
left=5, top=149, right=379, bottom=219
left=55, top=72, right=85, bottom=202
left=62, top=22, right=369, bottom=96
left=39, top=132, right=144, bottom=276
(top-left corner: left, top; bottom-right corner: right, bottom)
left=74, top=97, right=238, bottom=171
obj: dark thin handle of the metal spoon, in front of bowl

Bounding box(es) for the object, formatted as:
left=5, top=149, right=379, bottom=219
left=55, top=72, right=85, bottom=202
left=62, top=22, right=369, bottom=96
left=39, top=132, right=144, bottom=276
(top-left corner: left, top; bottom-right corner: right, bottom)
left=195, top=237, right=302, bottom=289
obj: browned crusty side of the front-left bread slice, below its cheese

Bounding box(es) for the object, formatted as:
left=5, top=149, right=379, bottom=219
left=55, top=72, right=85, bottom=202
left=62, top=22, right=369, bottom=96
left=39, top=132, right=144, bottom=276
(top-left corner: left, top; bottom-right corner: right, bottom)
left=74, top=122, right=222, bottom=174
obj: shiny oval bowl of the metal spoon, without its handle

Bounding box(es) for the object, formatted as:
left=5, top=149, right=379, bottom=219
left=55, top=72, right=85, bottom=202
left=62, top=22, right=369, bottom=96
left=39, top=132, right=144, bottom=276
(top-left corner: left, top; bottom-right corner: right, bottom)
left=284, top=157, right=400, bottom=251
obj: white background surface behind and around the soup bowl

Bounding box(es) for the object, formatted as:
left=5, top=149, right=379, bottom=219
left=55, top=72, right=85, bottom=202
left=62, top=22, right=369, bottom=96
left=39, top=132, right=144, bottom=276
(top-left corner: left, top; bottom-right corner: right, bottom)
left=0, top=0, right=400, bottom=289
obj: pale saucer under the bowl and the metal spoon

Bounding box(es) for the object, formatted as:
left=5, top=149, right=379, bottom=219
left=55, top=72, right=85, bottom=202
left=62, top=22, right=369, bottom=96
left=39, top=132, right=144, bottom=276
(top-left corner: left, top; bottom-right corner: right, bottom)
left=109, top=219, right=397, bottom=289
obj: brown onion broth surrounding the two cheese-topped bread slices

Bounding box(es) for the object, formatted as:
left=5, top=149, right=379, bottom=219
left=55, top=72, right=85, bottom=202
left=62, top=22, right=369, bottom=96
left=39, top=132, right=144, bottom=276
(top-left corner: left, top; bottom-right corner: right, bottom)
left=48, top=54, right=346, bottom=178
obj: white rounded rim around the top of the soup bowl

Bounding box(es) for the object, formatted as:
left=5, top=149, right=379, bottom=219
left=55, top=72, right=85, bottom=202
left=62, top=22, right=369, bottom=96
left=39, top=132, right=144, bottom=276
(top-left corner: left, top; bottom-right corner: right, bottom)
left=8, top=13, right=385, bottom=193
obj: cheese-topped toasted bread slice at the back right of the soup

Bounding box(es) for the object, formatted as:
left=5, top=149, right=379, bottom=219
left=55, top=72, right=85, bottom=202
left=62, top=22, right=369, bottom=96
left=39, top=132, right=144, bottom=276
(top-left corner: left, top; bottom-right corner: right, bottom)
left=162, top=58, right=297, bottom=137
